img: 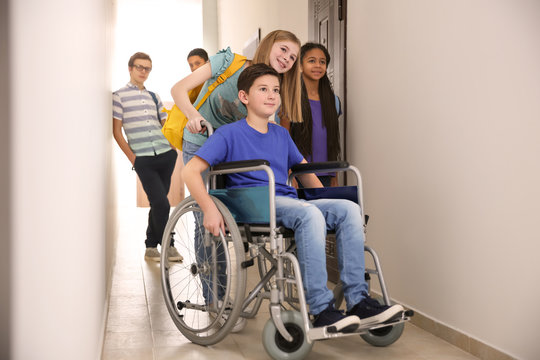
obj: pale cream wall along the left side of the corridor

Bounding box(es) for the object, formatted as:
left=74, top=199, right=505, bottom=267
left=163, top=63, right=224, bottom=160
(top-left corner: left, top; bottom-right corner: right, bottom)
left=8, top=0, right=112, bottom=360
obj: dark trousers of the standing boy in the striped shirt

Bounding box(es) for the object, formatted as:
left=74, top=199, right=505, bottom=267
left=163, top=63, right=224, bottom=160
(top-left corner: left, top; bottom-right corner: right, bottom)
left=135, top=149, right=178, bottom=248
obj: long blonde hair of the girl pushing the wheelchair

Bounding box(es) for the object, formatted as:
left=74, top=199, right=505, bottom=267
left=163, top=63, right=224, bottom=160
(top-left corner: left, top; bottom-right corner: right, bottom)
left=253, top=30, right=303, bottom=122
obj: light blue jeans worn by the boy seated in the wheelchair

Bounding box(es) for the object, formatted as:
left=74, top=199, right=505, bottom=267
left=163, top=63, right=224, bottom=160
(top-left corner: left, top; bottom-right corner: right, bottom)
left=276, top=196, right=368, bottom=315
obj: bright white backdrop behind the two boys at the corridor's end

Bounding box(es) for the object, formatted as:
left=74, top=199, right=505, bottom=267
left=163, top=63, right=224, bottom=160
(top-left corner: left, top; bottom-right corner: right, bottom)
left=111, top=0, right=203, bottom=101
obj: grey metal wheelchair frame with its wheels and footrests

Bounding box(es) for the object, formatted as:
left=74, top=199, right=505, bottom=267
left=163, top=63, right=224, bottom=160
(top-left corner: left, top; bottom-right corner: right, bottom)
left=161, top=123, right=412, bottom=359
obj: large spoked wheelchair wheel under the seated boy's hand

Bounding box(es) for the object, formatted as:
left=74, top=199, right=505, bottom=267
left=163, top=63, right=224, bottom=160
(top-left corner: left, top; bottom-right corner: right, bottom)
left=161, top=197, right=246, bottom=345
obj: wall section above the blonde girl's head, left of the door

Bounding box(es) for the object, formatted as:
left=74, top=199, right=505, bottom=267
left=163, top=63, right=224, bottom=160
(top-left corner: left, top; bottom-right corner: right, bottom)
left=217, top=0, right=308, bottom=54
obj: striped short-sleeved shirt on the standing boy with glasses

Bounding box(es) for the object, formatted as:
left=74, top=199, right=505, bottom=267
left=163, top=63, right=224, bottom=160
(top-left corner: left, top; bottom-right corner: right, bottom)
left=113, top=83, right=171, bottom=156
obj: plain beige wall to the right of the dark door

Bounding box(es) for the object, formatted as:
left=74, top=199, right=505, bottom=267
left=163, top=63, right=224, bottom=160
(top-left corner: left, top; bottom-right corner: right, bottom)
left=347, top=0, right=540, bottom=359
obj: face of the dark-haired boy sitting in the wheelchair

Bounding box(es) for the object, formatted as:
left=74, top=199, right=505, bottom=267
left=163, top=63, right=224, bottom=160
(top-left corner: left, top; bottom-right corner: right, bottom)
left=238, top=75, right=281, bottom=118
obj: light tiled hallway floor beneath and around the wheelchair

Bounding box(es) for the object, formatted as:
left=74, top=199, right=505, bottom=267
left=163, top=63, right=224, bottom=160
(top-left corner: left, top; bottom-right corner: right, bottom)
left=102, top=206, right=477, bottom=360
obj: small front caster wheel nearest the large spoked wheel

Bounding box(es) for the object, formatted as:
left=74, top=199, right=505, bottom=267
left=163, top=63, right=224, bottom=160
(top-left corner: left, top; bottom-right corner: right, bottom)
left=263, top=311, right=313, bottom=360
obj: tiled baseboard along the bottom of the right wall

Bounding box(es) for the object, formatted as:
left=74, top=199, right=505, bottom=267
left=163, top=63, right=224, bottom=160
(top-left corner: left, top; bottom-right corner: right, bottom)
left=372, top=291, right=516, bottom=360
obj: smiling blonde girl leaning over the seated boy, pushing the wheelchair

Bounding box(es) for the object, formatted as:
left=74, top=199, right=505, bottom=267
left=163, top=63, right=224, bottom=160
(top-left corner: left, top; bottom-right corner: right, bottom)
left=171, top=30, right=302, bottom=164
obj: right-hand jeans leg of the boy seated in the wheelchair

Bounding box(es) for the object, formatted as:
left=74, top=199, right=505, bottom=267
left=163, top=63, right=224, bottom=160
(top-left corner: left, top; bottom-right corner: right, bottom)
left=310, top=199, right=368, bottom=310
